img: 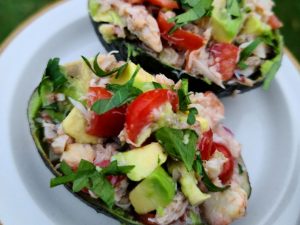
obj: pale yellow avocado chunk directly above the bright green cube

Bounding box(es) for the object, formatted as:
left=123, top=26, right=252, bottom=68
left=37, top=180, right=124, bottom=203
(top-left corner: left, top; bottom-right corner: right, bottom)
left=112, top=142, right=167, bottom=181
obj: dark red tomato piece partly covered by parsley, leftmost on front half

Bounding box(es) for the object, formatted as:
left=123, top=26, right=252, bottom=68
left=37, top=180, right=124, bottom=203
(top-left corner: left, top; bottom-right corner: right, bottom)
left=86, top=87, right=126, bottom=137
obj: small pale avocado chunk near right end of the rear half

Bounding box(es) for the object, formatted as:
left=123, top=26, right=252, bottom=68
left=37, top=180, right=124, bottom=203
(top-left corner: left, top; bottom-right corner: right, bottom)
left=242, top=15, right=271, bottom=36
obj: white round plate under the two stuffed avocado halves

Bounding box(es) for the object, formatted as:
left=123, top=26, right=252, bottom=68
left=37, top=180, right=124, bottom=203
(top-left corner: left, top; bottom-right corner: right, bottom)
left=0, top=0, right=300, bottom=225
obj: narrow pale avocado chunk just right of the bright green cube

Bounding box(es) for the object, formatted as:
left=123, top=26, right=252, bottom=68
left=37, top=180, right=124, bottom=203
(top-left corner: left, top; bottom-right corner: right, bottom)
left=168, top=162, right=210, bottom=206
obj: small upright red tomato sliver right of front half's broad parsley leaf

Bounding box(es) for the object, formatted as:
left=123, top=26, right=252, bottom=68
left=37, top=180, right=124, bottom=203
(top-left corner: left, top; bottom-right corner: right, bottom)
left=198, top=129, right=216, bottom=160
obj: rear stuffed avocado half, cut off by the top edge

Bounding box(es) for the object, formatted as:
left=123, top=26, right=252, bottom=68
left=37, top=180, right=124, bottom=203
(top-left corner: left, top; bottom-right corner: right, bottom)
left=89, top=0, right=283, bottom=97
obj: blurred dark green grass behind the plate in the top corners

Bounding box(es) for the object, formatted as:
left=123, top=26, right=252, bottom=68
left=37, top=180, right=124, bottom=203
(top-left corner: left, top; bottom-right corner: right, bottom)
left=0, top=0, right=300, bottom=61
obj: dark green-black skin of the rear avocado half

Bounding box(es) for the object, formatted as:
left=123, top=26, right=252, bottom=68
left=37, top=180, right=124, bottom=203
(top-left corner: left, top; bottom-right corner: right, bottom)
left=90, top=17, right=264, bottom=97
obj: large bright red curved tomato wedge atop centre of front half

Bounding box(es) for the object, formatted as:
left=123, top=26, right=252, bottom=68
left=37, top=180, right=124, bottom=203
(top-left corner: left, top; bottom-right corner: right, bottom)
left=125, top=89, right=178, bottom=143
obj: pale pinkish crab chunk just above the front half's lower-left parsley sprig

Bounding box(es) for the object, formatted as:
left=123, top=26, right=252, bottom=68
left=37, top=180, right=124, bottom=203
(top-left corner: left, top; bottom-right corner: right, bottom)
left=60, top=143, right=95, bottom=168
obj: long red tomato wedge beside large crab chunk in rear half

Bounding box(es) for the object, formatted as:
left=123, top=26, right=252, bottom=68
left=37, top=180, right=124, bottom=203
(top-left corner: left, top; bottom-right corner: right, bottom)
left=157, top=12, right=204, bottom=51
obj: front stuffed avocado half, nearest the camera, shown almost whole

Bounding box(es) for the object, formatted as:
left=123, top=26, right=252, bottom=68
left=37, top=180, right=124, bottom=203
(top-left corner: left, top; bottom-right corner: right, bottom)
left=28, top=54, right=251, bottom=225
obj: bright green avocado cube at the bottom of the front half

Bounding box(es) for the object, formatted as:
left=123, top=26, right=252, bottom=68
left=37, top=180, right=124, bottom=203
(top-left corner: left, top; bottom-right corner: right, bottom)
left=129, top=167, right=175, bottom=214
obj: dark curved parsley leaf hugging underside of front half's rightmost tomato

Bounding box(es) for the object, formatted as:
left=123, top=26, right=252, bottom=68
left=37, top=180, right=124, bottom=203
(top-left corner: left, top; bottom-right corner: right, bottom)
left=194, top=155, right=230, bottom=192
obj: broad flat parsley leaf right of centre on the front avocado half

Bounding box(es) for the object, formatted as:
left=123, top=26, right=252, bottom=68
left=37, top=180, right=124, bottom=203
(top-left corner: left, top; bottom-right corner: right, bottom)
left=155, top=127, right=198, bottom=171
